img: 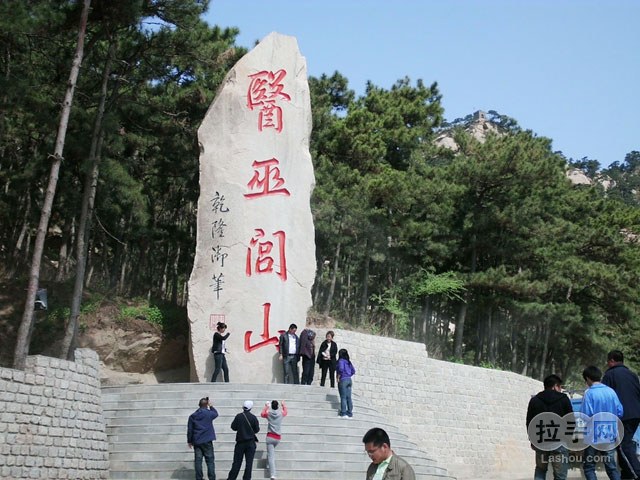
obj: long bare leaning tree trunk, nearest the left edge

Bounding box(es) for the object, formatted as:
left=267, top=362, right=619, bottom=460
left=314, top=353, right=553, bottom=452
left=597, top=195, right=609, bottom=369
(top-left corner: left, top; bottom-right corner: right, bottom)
left=13, top=0, right=91, bottom=370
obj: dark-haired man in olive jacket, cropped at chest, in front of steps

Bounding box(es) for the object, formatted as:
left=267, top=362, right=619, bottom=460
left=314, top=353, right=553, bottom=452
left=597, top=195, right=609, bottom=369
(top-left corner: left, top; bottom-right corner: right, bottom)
left=362, top=428, right=416, bottom=480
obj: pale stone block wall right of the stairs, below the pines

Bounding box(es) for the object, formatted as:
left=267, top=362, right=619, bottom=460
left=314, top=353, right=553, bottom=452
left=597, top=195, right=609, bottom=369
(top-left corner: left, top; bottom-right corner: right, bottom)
left=316, top=329, right=542, bottom=480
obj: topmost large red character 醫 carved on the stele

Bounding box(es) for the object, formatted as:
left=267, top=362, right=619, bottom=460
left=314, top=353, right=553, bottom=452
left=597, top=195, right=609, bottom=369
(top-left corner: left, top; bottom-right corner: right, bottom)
left=247, top=69, right=291, bottom=133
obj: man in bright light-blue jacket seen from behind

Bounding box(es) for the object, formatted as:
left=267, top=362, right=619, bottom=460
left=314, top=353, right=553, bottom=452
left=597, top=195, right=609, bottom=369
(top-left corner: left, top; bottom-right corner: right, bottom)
left=580, top=366, right=623, bottom=480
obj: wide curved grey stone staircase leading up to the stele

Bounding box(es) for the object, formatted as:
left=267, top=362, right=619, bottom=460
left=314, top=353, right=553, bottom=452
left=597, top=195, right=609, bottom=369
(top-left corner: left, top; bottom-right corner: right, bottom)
left=102, top=383, right=453, bottom=480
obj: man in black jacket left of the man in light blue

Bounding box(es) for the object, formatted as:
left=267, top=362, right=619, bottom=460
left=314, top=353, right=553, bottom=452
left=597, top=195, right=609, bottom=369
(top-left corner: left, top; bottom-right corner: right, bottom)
left=527, top=375, right=573, bottom=480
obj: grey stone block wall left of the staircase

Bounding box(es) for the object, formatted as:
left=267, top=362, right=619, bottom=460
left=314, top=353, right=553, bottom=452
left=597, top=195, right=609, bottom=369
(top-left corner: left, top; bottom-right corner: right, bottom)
left=0, top=349, right=109, bottom=479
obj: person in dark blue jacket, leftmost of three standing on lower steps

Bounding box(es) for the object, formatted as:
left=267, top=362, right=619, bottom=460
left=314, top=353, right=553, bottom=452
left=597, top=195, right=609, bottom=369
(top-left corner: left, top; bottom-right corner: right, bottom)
left=187, top=397, right=218, bottom=480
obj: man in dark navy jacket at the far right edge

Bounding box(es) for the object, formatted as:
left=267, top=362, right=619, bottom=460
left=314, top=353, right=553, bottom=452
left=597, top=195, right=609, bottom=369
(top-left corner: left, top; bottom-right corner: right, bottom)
left=602, top=350, right=640, bottom=479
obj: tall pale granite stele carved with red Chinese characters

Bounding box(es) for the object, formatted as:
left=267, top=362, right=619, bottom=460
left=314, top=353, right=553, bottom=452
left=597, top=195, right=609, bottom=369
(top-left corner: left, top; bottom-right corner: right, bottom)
left=188, top=33, right=315, bottom=383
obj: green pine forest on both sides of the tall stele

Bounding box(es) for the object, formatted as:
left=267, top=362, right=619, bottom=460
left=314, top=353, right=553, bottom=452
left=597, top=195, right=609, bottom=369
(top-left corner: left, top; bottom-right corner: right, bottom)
left=0, top=0, right=640, bottom=377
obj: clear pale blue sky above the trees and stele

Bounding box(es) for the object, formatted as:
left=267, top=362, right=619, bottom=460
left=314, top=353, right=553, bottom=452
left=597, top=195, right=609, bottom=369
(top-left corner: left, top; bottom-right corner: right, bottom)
left=205, top=0, right=640, bottom=166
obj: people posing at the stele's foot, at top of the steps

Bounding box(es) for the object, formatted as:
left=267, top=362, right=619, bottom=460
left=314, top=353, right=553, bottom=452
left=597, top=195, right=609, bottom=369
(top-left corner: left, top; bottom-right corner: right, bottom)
left=211, top=322, right=356, bottom=418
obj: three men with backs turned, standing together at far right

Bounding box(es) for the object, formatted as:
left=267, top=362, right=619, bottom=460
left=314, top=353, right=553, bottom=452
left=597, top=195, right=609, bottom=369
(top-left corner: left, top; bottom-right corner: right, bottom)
left=526, top=350, right=640, bottom=480
